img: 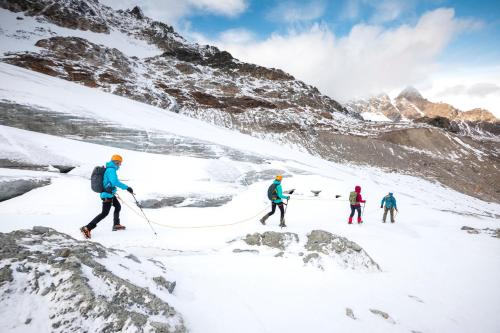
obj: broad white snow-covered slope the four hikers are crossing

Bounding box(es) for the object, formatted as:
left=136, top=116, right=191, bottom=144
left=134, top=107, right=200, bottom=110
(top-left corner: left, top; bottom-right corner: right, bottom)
left=0, top=65, right=500, bottom=333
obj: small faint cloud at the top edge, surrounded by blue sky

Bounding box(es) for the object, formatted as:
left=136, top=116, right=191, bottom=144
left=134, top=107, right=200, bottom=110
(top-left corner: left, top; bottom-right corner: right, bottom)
left=267, top=0, right=326, bottom=23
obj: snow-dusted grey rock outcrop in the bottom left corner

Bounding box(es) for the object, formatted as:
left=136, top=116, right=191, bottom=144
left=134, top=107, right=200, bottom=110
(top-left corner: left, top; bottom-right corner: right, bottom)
left=0, top=228, right=187, bottom=333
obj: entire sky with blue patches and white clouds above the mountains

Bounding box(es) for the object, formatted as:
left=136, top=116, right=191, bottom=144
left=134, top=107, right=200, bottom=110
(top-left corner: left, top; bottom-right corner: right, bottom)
left=101, top=0, right=500, bottom=115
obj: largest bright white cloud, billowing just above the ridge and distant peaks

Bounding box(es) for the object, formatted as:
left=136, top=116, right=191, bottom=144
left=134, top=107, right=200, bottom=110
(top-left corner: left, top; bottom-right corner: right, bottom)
left=200, top=9, right=480, bottom=101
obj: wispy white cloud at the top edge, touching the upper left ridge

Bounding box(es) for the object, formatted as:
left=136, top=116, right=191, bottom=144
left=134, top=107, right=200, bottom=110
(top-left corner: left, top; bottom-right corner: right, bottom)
left=101, top=0, right=248, bottom=26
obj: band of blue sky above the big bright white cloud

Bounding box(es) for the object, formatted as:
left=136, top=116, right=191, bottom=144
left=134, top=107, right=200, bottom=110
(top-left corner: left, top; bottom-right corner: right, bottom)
left=188, top=0, right=500, bottom=65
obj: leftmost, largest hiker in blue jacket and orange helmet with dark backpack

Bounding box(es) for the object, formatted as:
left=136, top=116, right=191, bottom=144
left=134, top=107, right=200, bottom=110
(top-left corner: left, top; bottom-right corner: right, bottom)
left=80, top=155, right=134, bottom=239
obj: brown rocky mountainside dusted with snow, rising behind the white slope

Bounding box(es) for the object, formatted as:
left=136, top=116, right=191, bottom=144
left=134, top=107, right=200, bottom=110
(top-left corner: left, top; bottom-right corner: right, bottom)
left=0, top=0, right=500, bottom=200
